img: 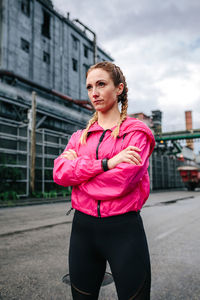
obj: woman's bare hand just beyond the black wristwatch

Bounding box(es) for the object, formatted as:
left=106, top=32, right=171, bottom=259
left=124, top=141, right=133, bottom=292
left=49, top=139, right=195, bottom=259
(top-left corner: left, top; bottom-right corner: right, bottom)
left=108, top=146, right=142, bottom=169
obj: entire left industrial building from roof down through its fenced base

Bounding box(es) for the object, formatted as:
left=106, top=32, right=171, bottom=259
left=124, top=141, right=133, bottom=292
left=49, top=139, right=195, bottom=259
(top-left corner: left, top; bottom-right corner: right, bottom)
left=0, top=0, right=113, bottom=196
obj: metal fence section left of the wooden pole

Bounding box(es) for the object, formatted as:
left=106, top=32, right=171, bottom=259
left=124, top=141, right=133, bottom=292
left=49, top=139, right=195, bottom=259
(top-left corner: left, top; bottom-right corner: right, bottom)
left=0, top=118, right=29, bottom=196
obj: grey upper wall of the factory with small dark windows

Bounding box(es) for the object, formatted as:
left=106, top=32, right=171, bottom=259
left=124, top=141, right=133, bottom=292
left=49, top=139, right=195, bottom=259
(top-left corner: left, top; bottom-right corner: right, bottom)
left=0, top=0, right=112, bottom=99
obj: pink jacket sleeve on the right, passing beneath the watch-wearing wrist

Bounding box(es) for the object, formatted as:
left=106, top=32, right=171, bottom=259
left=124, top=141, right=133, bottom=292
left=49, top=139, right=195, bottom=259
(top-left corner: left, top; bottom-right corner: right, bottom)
left=79, top=131, right=150, bottom=200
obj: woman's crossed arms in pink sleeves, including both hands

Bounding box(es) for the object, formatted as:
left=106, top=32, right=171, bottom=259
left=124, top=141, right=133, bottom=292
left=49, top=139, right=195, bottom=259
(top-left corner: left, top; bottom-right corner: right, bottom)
left=54, top=132, right=150, bottom=200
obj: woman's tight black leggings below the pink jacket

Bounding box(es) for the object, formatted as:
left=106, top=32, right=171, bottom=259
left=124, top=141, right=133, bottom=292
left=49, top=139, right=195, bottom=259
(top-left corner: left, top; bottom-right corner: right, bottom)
left=69, top=211, right=151, bottom=300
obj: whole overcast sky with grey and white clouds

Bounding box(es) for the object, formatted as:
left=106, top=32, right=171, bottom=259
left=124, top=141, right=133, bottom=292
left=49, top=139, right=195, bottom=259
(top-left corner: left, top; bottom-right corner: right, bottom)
left=53, top=0, right=200, bottom=150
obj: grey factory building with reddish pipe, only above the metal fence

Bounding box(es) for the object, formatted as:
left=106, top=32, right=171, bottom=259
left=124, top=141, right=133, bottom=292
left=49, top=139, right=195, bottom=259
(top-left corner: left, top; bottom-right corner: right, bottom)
left=0, top=0, right=112, bottom=133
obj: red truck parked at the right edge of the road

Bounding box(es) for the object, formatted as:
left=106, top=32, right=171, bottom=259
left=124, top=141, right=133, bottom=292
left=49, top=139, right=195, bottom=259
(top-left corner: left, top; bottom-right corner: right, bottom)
left=178, top=166, right=200, bottom=191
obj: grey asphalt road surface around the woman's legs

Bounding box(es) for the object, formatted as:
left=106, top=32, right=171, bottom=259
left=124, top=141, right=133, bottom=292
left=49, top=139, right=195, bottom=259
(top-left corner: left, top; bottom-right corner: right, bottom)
left=0, top=191, right=200, bottom=300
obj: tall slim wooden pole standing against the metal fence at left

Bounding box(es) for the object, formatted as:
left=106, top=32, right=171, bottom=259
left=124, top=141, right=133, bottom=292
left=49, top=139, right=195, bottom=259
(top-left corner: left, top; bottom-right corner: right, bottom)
left=30, top=92, right=36, bottom=194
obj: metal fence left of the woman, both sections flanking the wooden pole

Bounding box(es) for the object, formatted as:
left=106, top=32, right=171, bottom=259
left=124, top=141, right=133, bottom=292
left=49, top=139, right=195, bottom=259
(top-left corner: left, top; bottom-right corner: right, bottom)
left=0, top=118, right=70, bottom=196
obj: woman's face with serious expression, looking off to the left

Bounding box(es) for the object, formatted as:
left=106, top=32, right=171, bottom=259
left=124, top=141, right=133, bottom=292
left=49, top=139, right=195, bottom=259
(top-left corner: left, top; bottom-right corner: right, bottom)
left=86, top=68, right=123, bottom=112
